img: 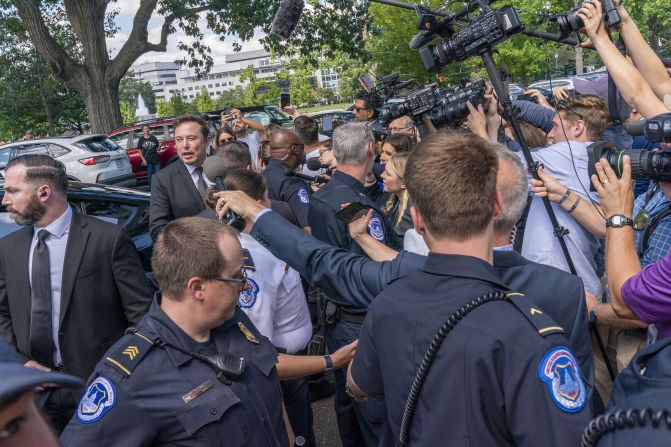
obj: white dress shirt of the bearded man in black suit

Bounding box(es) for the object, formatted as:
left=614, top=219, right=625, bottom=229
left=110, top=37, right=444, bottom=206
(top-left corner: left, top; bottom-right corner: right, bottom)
left=28, top=206, right=72, bottom=366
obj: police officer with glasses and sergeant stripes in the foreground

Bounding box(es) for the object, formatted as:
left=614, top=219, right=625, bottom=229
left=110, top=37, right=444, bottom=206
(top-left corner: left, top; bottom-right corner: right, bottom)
left=61, top=217, right=289, bottom=447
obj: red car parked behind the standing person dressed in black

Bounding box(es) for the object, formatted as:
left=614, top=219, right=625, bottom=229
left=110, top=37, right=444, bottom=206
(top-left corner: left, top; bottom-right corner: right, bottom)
left=107, top=117, right=177, bottom=180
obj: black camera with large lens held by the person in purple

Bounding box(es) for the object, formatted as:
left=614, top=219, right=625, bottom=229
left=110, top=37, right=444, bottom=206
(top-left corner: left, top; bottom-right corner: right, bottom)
left=587, top=141, right=671, bottom=186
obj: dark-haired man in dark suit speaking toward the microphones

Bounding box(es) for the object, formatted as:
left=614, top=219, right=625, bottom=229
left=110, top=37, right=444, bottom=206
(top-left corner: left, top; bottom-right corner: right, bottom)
left=149, top=115, right=214, bottom=240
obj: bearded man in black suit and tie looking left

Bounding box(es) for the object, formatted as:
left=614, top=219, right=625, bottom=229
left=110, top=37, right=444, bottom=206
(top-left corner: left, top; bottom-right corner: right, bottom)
left=0, top=155, right=151, bottom=430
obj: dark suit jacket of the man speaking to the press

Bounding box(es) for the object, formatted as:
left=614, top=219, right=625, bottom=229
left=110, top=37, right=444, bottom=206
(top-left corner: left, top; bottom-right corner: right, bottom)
left=149, top=161, right=205, bottom=240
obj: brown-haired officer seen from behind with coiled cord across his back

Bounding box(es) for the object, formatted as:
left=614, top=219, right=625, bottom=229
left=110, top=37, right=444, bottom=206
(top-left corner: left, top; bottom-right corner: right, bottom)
left=348, top=134, right=591, bottom=446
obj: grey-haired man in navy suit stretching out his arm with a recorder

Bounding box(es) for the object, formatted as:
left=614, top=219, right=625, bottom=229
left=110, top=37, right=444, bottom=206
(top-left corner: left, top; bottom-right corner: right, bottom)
left=214, top=147, right=594, bottom=383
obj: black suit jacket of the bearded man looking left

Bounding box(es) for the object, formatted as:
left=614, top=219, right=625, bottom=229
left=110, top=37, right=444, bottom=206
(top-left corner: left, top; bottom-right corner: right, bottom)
left=0, top=211, right=151, bottom=380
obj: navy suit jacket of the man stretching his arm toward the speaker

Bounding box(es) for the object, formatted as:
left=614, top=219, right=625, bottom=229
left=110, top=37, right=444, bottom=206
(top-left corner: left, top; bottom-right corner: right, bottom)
left=251, top=212, right=594, bottom=383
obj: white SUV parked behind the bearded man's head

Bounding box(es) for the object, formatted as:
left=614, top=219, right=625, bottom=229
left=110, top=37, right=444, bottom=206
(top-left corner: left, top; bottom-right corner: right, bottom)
left=0, top=135, right=136, bottom=186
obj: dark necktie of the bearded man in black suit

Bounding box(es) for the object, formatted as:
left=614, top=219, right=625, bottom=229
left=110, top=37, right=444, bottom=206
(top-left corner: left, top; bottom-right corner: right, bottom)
left=30, top=230, right=55, bottom=366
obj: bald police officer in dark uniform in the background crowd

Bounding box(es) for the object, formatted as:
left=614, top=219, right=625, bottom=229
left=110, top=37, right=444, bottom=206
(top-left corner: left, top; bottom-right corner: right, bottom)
left=261, top=129, right=311, bottom=231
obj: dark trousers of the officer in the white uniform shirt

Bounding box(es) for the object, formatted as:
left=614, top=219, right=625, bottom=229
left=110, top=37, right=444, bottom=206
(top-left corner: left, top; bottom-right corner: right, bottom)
left=280, top=377, right=316, bottom=447
